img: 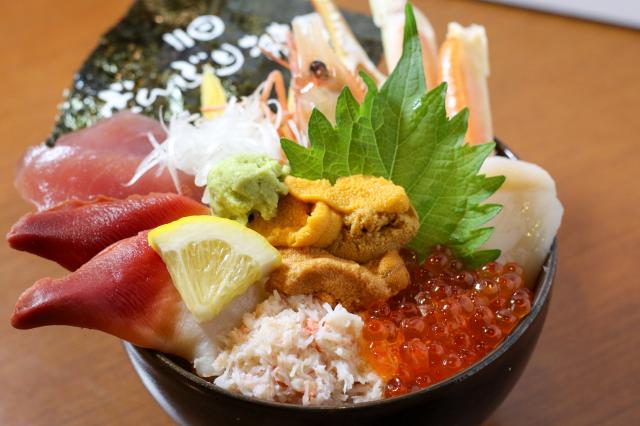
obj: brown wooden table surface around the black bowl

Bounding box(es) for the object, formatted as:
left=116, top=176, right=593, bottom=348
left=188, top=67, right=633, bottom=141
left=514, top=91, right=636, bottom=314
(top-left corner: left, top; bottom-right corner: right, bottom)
left=0, top=0, right=640, bottom=426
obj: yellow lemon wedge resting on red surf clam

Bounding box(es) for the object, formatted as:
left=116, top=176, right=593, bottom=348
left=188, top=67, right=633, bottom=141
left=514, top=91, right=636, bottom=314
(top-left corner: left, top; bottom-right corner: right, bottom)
left=148, top=216, right=282, bottom=322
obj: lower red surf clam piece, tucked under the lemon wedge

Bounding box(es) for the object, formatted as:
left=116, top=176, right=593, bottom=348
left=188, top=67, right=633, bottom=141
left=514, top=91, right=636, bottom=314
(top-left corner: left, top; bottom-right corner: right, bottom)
left=11, top=232, right=217, bottom=360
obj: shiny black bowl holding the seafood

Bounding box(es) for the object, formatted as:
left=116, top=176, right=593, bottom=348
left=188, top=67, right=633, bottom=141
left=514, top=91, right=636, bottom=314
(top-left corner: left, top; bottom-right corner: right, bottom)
left=125, top=143, right=557, bottom=426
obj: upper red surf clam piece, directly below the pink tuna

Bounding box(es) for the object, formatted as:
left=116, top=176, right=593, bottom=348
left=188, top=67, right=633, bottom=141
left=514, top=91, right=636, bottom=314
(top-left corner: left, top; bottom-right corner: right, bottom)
left=7, top=194, right=209, bottom=271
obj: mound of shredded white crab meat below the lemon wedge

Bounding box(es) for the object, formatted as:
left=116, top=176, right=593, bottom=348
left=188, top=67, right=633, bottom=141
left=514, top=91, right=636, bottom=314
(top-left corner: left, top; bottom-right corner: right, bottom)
left=213, top=292, right=383, bottom=405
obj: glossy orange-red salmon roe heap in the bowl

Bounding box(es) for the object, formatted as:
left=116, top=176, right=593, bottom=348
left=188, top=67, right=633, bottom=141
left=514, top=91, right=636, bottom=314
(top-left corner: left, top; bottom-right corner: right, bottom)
left=361, top=246, right=532, bottom=397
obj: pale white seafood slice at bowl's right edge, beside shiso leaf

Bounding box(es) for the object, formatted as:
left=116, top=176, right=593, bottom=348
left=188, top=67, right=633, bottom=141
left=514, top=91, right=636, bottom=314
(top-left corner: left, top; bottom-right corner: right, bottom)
left=480, top=157, right=564, bottom=287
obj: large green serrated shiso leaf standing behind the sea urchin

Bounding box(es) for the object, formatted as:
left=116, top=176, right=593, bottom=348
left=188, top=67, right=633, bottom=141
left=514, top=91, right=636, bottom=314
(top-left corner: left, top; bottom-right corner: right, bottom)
left=282, top=4, right=504, bottom=266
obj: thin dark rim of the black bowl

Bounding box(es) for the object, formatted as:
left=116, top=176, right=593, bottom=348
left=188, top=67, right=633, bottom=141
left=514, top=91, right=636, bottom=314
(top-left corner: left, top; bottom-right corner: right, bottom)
left=129, top=139, right=558, bottom=413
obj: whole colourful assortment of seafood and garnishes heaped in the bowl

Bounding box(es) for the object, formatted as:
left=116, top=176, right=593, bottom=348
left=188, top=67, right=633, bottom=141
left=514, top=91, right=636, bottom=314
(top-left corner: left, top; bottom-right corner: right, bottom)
left=7, top=0, right=563, bottom=407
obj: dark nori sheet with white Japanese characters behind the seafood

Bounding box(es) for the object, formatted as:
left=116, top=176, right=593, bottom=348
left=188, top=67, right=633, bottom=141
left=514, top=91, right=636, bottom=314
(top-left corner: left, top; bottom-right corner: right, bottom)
left=47, top=0, right=381, bottom=144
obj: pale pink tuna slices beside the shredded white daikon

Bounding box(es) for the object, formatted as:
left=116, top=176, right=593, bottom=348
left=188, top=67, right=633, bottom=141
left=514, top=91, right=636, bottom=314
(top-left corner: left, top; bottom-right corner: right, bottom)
left=15, top=113, right=203, bottom=210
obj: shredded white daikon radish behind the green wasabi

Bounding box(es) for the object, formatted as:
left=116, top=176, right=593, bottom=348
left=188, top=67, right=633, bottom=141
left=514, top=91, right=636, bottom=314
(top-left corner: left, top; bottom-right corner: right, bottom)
left=127, top=84, right=282, bottom=203
